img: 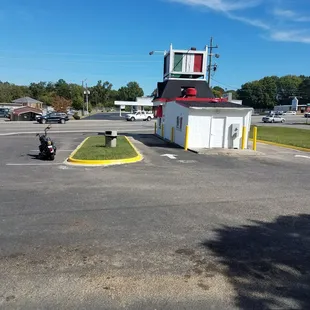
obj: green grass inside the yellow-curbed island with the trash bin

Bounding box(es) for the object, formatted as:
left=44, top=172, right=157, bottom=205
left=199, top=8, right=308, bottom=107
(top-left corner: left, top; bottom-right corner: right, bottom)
left=73, top=136, right=137, bottom=160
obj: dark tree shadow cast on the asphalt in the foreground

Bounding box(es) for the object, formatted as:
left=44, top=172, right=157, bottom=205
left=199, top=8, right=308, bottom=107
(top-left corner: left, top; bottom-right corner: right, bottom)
left=203, top=214, right=310, bottom=309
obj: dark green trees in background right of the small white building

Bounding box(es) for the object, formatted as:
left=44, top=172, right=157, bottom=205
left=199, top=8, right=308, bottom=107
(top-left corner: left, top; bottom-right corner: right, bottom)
left=212, top=75, right=310, bottom=109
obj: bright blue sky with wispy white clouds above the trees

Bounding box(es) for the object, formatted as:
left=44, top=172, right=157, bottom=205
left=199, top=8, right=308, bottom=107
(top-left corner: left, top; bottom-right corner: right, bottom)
left=0, top=0, right=310, bottom=94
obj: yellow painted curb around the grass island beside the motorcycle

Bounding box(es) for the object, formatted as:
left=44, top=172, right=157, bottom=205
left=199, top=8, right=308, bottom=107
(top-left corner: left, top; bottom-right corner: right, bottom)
left=68, top=136, right=143, bottom=166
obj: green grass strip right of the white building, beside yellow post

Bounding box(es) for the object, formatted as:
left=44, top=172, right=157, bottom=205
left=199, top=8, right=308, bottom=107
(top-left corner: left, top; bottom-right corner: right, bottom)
left=250, top=126, right=310, bottom=149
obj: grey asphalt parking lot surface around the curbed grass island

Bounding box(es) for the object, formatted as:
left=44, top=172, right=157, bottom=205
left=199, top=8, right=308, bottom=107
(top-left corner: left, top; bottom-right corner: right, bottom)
left=0, top=133, right=310, bottom=309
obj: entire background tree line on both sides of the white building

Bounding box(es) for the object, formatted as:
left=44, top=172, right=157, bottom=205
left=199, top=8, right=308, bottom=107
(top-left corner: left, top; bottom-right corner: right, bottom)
left=0, top=75, right=310, bottom=110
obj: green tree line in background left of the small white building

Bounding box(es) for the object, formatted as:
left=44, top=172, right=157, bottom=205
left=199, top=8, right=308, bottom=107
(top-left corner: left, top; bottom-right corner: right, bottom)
left=0, top=79, right=144, bottom=110
